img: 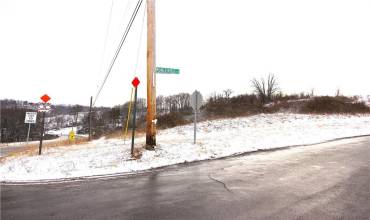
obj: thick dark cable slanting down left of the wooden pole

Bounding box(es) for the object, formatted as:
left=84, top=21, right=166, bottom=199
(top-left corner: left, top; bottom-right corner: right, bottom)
left=93, top=0, right=143, bottom=106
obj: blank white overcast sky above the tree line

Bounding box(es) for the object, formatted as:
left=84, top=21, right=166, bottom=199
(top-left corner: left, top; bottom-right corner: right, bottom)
left=0, top=0, right=370, bottom=106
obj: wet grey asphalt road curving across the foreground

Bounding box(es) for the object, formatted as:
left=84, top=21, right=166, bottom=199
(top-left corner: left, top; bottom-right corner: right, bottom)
left=1, top=137, right=370, bottom=220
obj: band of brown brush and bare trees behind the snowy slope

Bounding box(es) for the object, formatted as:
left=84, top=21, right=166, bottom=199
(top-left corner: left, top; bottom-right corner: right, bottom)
left=0, top=74, right=370, bottom=142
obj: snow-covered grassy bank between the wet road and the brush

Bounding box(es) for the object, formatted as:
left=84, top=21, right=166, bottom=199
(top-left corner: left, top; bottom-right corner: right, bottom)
left=0, top=113, right=370, bottom=181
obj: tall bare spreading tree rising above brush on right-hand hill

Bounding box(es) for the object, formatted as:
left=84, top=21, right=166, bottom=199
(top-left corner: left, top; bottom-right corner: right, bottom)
left=252, top=74, right=279, bottom=104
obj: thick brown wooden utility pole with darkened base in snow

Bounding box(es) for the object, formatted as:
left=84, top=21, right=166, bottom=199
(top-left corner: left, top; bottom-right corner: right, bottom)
left=146, top=0, right=157, bottom=149
